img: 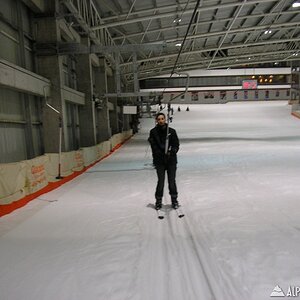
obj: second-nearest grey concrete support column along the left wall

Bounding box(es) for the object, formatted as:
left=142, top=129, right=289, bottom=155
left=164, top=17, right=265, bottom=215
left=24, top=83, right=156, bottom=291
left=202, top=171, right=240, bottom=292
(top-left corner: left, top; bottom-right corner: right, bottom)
left=76, top=38, right=97, bottom=147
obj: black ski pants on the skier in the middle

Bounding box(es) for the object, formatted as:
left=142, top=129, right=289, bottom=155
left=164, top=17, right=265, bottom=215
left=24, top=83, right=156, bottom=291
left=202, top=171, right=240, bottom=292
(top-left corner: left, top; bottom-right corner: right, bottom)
left=155, top=163, right=178, bottom=200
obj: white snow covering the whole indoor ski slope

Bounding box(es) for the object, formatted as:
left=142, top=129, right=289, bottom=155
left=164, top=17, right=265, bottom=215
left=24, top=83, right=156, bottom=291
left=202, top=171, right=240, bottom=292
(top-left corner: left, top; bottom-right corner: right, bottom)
left=0, top=102, right=300, bottom=300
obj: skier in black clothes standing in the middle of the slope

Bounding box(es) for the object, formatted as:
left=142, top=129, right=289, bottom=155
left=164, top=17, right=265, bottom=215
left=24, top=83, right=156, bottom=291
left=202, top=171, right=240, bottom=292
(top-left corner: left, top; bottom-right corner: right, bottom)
left=148, top=113, right=179, bottom=210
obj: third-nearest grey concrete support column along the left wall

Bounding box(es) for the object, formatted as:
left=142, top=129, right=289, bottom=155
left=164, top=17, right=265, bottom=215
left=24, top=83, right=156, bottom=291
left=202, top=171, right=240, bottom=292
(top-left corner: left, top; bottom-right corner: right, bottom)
left=95, top=58, right=111, bottom=143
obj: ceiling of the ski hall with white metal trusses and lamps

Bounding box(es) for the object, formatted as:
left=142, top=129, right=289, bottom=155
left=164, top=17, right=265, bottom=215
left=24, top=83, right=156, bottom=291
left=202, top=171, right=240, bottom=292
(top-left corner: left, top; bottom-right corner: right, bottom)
left=61, top=0, right=300, bottom=80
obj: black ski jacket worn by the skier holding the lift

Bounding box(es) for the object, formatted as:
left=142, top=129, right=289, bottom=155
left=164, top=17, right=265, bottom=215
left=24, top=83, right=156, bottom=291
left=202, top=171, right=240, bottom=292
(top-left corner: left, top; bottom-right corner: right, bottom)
left=148, top=125, right=179, bottom=166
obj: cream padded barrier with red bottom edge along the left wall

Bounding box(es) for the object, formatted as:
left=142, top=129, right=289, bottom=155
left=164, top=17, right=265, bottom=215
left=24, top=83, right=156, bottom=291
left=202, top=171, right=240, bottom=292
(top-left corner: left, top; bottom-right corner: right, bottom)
left=0, top=130, right=132, bottom=217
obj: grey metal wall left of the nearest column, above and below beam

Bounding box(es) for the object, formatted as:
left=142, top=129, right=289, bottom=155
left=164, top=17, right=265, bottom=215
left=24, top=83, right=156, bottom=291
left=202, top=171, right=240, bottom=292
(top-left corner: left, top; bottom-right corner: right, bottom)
left=0, top=0, right=43, bottom=163
